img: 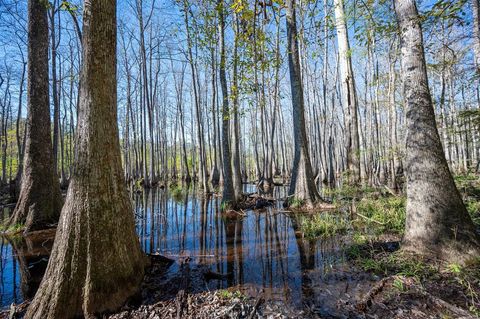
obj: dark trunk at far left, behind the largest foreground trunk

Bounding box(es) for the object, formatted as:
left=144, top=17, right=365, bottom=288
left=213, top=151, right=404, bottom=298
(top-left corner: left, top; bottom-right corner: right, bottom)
left=7, top=0, right=62, bottom=232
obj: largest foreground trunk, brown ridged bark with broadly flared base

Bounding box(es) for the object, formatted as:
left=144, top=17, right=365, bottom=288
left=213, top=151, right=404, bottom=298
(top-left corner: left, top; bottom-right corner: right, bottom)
left=26, top=0, right=145, bottom=319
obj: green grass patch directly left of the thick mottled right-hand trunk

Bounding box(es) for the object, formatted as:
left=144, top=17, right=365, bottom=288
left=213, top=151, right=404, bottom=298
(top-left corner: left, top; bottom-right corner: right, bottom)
left=356, top=196, right=406, bottom=234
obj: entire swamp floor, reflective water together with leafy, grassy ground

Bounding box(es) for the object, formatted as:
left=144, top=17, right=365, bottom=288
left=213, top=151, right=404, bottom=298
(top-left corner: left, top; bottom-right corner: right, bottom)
left=0, top=185, right=480, bottom=319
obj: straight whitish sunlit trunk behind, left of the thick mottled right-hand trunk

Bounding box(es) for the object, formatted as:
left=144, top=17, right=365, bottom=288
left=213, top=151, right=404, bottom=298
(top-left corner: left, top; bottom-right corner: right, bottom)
left=334, top=0, right=360, bottom=185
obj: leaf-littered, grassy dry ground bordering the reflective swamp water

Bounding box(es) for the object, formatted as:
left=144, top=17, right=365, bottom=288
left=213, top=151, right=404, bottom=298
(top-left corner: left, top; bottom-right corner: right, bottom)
left=0, top=176, right=480, bottom=319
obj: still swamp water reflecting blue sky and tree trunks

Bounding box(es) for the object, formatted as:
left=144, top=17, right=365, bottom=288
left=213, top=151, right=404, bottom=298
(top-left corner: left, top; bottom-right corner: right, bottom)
left=0, top=185, right=378, bottom=316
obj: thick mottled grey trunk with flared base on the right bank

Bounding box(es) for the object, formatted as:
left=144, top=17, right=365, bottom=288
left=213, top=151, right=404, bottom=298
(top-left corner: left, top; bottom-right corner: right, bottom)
left=394, top=0, right=480, bottom=262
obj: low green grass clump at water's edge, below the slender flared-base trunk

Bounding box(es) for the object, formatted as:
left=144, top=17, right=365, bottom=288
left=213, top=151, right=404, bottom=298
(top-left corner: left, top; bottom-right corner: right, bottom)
left=299, top=213, right=350, bottom=239
